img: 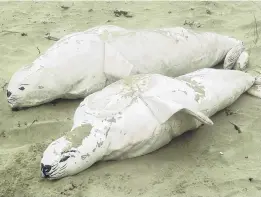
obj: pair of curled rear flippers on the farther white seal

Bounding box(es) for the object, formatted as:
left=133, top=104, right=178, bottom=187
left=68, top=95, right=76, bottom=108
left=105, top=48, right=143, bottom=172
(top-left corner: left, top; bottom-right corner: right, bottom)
left=223, top=42, right=248, bottom=70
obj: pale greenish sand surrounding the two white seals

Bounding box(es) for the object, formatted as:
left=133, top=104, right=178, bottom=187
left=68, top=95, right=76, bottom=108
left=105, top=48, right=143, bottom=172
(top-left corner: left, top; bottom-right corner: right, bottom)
left=0, top=1, right=261, bottom=197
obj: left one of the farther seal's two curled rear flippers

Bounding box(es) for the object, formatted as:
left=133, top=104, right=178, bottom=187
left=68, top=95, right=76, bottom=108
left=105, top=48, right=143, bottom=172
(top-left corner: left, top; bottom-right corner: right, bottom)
left=223, top=42, right=245, bottom=70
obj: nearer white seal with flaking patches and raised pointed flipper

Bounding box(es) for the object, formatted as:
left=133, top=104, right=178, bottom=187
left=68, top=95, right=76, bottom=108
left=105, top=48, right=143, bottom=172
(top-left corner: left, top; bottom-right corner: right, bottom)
left=41, top=68, right=255, bottom=179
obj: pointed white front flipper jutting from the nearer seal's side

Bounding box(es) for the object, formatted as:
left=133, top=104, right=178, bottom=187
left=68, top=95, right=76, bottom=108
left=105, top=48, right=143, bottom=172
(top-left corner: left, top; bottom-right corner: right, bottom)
left=140, top=96, right=213, bottom=125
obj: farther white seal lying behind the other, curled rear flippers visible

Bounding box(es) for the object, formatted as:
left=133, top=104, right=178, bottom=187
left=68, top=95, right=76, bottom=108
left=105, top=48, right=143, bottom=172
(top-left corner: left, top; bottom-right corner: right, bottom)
left=7, top=25, right=248, bottom=109
